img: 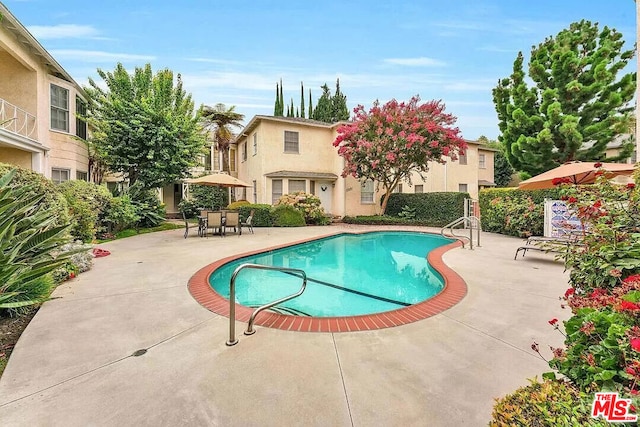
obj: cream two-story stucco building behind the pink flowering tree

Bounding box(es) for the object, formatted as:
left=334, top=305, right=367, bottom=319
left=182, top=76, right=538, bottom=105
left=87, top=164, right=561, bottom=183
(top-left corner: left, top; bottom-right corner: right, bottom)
left=234, top=115, right=495, bottom=216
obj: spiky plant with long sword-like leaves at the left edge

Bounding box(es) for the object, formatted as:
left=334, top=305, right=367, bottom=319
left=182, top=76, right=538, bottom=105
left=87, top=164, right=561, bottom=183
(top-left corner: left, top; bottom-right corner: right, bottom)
left=0, top=171, right=72, bottom=315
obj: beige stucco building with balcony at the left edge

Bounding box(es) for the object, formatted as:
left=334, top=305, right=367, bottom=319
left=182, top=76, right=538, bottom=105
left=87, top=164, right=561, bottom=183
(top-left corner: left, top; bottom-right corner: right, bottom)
left=0, top=3, right=89, bottom=183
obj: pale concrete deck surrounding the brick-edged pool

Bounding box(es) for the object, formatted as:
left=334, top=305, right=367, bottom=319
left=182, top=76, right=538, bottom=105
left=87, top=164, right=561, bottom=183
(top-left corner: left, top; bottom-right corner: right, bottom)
left=0, top=225, right=570, bottom=426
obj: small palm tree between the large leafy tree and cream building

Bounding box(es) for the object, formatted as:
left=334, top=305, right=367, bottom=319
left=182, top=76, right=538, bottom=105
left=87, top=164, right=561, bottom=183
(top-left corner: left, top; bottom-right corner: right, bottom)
left=202, top=103, right=244, bottom=172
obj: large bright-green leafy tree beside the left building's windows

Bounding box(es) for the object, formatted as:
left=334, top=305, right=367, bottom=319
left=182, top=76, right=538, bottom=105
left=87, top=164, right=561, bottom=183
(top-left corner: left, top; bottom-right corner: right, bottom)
left=85, top=64, right=204, bottom=188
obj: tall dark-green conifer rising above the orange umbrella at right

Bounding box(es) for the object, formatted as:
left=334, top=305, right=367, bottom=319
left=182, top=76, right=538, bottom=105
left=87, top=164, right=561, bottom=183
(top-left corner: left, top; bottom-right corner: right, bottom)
left=493, top=20, right=636, bottom=175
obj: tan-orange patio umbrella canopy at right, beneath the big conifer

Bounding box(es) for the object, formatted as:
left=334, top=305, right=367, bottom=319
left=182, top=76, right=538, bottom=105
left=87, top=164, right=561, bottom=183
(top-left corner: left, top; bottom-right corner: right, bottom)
left=518, top=162, right=635, bottom=190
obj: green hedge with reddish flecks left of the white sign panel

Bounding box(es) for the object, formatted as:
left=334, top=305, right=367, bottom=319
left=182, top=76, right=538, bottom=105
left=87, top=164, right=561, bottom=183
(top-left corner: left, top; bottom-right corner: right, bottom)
left=479, top=188, right=560, bottom=237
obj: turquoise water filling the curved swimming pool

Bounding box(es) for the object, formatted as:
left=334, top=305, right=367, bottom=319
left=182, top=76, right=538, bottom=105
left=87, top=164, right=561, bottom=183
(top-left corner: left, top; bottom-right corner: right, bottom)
left=209, top=231, right=451, bottom=317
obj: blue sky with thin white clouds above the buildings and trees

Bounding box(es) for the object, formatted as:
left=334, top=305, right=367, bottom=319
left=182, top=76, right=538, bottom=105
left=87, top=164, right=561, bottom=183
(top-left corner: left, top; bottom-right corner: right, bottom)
left=4, top=0, right=636, bottom=139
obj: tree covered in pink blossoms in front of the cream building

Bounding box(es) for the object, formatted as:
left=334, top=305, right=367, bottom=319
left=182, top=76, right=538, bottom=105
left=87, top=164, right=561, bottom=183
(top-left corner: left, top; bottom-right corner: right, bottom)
left=333, top=96, right=467, bottom=215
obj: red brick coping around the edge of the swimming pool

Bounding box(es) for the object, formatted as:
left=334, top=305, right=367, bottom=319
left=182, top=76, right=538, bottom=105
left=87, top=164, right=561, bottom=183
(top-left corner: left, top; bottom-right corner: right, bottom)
left=188, top=231, right=467, bottom=332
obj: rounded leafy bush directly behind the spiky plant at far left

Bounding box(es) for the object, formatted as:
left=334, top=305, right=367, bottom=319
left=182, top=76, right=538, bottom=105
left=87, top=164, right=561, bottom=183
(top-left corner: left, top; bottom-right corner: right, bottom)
left=0, top=163, right=71, bottom=229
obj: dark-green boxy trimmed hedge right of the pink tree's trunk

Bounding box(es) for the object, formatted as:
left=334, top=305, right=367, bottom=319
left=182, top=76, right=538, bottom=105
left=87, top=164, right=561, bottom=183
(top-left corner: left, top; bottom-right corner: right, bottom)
left=386, top=193, right=469, bottom=227
